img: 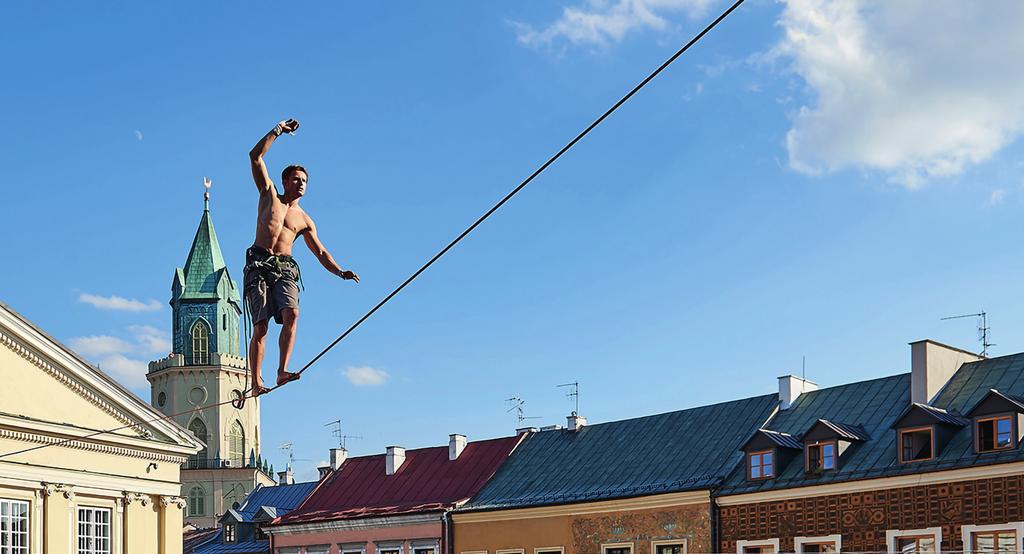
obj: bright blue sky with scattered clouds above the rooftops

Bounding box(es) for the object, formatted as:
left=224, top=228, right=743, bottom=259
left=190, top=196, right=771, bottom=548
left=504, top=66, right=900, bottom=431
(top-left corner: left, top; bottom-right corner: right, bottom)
left=0, top=0, right=1024, bottom=478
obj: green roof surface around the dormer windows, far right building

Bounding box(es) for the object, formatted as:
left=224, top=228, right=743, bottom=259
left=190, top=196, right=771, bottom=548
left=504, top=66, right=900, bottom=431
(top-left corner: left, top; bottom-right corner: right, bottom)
left=719, top=353, right=1024, bottom=495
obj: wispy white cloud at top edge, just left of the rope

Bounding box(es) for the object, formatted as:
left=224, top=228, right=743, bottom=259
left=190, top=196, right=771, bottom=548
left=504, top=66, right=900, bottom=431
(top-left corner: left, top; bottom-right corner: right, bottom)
left=513, top=0, right=716, bottom=46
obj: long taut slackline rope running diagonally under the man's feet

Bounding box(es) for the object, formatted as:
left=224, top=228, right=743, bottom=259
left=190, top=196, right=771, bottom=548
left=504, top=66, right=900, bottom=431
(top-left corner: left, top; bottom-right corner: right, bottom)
left=0, top=0, right=745, bottom=459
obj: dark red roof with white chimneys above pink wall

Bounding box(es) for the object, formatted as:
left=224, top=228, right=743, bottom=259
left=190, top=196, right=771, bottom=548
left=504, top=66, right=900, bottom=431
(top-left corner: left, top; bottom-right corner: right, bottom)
left=273, top=435, right=521, bottom=524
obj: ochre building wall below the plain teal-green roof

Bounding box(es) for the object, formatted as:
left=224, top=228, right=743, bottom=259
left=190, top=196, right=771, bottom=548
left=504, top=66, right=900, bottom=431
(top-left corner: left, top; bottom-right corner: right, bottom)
left=454, top=492, right=711, bottom=554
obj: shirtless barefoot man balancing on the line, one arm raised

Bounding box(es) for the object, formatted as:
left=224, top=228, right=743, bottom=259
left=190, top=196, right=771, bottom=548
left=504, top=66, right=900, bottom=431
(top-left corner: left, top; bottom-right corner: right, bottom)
left=243, top=119, right=359, bottom=396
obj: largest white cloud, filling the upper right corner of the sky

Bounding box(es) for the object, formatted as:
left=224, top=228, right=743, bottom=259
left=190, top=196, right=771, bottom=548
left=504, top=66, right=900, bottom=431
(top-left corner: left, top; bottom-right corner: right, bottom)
left=772, top=0, right=1024, bottom=187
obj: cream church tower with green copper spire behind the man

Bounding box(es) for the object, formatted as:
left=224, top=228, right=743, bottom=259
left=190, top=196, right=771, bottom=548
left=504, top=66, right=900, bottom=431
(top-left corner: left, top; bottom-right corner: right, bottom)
left=146, top=181, right=273, bottom=527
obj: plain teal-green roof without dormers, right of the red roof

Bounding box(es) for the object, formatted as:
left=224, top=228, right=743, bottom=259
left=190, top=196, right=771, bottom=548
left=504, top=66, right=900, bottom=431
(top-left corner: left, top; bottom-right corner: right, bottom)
left=460, top=394, right=778, bottom=511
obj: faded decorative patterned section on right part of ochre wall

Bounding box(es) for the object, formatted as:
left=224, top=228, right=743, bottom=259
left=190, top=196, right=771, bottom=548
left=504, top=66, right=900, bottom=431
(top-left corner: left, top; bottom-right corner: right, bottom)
left=571, top=504, right=711, bottom=554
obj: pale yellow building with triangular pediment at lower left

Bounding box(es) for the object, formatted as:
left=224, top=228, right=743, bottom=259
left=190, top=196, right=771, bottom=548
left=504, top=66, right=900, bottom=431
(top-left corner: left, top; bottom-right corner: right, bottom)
left=0, top=303, right=203, bottom=554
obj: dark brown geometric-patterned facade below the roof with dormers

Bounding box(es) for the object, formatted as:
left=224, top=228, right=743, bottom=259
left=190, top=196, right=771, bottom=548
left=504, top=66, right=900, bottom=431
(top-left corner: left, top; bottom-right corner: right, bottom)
left=716, top=475, right=1024, bottom=552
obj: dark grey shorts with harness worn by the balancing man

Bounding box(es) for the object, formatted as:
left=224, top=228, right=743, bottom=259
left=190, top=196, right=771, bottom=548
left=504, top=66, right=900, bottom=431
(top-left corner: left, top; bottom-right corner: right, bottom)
left=244, top=247, right=299, bottom=324
